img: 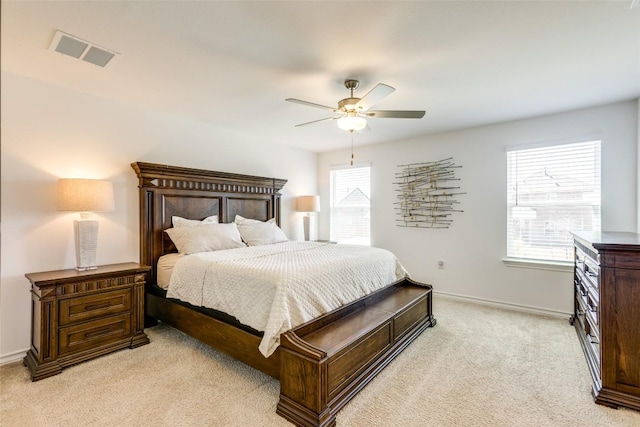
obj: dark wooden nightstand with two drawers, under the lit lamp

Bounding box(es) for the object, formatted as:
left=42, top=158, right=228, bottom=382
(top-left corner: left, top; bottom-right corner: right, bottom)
left=23, top=263, right=151, bottom=381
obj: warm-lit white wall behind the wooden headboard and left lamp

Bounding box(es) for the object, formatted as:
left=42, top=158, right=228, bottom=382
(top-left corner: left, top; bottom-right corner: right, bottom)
left=0, top=72, right=317, bottom=363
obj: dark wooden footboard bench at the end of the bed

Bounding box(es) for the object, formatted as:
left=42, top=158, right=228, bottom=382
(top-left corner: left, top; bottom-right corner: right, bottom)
left=277, top=279, right=436, bottom=427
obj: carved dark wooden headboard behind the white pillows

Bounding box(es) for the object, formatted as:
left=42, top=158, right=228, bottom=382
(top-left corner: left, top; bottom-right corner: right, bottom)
left=131, top=162, right=287, bottom=284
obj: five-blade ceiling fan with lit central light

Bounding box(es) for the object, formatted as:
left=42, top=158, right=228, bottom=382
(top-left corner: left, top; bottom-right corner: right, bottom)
left=285, top=79, right=424, bottom=132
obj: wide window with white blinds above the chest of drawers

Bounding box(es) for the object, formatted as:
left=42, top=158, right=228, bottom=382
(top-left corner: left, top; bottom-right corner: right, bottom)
left=507, top=141, right=600, bottom=261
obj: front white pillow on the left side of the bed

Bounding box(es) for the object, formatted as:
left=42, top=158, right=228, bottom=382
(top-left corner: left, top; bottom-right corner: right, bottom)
left=165, top=222, right=245, bottom=255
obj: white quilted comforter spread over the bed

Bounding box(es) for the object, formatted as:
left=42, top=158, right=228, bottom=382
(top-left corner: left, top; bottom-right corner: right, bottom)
left=167, top=242, right=407, bottom=357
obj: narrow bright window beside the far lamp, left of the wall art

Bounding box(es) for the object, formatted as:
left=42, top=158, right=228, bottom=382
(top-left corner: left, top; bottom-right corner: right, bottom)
left=329, top=166, right=371, bottom=245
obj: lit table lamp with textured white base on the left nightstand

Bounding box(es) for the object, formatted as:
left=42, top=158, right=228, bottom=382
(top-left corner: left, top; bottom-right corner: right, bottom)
left=58, top=178, right=115, bottom=271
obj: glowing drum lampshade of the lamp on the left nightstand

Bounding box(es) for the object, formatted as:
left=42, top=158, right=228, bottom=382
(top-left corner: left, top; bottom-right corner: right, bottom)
left=58, top=178, right=115, bottom=212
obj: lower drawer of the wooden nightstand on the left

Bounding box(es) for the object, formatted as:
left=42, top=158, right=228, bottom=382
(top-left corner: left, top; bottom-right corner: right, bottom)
left=58, top=313, right=131, bottom=356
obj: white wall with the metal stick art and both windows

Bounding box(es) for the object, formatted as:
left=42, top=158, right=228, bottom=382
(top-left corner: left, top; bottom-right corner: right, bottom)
left=318, top=101, right=638, bottom=314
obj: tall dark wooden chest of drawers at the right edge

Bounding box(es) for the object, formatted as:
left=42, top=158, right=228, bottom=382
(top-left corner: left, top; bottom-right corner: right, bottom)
left=573, top=232, right=640, bottom=410
